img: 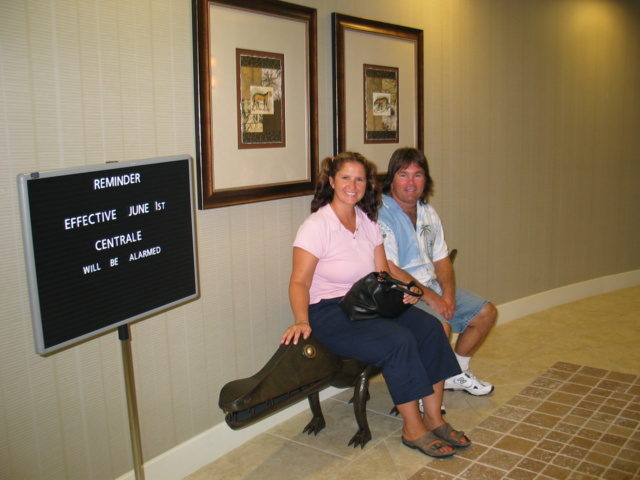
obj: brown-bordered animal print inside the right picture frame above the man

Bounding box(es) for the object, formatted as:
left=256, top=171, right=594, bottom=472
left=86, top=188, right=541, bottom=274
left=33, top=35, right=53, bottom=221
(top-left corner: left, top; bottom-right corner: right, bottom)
left=364, top=65, right=399, bottom=143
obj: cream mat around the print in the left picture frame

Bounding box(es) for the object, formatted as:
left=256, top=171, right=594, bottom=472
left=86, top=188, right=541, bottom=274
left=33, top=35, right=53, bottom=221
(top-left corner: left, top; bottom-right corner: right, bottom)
left=209, top=5, right=311, bottom=190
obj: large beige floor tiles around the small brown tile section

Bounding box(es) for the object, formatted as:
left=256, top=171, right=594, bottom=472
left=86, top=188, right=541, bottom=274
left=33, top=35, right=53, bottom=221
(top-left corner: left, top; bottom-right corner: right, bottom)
left=185, top=286, right=640, bottom=480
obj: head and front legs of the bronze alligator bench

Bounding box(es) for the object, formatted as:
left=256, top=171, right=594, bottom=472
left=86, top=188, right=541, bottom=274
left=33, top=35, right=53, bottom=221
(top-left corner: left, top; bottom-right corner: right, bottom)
left=218, top=335, right=380, bottom=448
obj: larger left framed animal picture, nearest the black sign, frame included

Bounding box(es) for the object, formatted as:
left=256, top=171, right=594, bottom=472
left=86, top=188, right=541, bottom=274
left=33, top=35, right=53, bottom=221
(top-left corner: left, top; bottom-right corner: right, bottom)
left=194, top=0, right=318, bottom=208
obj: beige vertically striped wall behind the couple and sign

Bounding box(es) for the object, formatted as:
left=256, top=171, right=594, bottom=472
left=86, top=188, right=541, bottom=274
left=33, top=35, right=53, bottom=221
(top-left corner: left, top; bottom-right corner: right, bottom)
left=0, top=0, right=640, bottom=480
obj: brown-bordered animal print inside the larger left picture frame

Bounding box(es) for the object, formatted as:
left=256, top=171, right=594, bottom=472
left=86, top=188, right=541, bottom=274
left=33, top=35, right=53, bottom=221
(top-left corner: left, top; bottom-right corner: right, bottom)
left=236, top=49, right=286, bottom=148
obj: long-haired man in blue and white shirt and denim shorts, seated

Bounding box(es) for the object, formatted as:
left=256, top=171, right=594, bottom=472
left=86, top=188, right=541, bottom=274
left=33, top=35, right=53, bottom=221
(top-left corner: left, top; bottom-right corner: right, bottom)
left=378, top=148, right=497, bottom=396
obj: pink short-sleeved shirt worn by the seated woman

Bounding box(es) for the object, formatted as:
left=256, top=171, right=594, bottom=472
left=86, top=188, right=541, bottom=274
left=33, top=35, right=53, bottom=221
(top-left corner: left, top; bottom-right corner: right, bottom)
left=293, top=205, right=382, bottom=304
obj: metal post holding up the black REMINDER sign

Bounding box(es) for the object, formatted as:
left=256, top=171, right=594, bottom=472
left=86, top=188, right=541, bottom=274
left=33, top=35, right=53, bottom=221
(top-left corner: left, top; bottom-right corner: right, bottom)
left=118, top=324, right=144, bottom=480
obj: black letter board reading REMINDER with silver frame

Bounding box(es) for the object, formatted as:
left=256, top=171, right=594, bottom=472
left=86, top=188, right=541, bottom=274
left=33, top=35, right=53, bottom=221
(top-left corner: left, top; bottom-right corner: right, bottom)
left=18, top=155, right=198, bottom=355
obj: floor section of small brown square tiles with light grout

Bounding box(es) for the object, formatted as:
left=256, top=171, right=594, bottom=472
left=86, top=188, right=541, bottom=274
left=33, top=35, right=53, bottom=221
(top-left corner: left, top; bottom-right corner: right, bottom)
left=410, top=362, right=640, bottom=480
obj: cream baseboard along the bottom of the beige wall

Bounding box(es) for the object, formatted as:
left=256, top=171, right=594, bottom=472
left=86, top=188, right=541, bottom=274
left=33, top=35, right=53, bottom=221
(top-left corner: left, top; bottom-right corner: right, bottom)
left=117, top=270, right=640, bottom=480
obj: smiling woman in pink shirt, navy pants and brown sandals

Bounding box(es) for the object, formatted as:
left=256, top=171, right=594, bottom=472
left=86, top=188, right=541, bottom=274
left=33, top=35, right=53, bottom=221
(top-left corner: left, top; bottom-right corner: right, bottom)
left=281, top=152, right=471, bottom=457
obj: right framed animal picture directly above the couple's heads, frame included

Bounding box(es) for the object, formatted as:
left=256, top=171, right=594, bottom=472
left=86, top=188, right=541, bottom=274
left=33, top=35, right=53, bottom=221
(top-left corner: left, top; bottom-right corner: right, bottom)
left=332, top=13, right=424, bottom=174
